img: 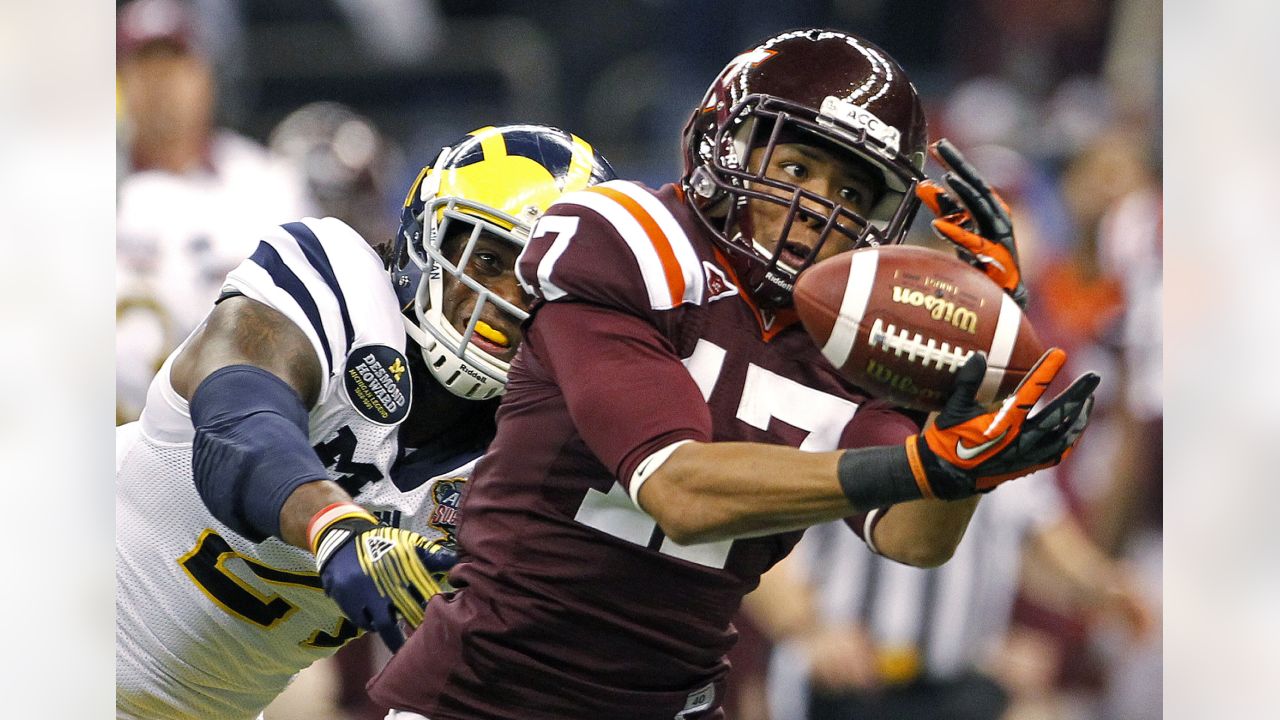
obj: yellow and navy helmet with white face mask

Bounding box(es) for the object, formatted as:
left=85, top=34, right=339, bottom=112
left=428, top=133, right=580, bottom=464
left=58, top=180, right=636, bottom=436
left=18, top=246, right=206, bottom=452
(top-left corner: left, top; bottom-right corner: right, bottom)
left=388, top=124, right=616, bottom=400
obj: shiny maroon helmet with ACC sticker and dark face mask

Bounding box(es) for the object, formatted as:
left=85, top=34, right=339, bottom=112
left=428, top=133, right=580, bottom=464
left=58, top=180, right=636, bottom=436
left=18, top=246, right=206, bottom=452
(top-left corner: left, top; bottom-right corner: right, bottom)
left=681, top=29, right=928, bottom=307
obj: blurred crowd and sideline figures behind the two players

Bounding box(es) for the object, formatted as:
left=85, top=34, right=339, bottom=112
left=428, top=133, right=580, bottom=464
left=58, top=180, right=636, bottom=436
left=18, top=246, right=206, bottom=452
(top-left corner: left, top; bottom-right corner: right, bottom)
left=116, top=0, right=1164, bottom=720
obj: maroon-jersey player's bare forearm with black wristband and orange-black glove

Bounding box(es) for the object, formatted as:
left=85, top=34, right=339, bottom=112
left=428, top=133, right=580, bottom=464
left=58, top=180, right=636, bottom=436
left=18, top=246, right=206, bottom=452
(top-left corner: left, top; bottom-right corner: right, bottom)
left=632, top=348, right=1097, bottom=565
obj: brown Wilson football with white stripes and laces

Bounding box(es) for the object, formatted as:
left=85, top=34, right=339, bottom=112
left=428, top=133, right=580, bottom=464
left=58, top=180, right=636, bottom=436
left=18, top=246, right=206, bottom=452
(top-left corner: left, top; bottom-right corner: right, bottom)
left=794, top=245, right=1044, bottom=410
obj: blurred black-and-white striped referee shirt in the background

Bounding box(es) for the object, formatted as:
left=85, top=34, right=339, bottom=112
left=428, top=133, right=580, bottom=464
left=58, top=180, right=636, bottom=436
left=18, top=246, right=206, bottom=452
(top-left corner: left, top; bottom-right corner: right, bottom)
left=769, top=470, right=1065, bottom=717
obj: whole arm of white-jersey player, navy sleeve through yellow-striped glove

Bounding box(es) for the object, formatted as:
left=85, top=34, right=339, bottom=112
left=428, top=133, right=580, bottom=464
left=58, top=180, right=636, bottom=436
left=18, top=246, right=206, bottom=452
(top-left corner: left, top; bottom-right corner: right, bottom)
left=172, top=297, right=456, bottom=651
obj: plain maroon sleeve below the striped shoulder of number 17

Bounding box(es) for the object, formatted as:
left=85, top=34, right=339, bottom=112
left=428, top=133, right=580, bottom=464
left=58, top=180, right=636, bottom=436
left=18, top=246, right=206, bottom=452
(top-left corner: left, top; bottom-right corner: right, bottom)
left=525, top=294, right=712, bottom=492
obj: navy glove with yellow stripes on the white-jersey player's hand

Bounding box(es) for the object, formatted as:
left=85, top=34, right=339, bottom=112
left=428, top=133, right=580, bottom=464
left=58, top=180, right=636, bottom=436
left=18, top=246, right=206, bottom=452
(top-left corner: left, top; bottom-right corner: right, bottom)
left=311, top=504, right=457, bottom=652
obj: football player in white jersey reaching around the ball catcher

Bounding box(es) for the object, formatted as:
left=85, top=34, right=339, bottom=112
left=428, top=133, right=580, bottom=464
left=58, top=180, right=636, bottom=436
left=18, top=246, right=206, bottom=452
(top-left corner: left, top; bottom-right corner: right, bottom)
left=115, top=126, right=613, bottom=720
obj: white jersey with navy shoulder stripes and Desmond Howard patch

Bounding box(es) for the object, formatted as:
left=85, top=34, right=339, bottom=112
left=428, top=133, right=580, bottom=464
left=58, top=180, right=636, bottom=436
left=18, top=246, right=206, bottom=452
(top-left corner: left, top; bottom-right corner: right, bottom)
left=115, top=218, right=472, bottom=720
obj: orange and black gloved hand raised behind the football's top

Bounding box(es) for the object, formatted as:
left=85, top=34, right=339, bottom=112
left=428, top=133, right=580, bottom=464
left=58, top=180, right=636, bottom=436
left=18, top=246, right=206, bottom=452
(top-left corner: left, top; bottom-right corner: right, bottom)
left=915, top=140, right=1027, bottom=309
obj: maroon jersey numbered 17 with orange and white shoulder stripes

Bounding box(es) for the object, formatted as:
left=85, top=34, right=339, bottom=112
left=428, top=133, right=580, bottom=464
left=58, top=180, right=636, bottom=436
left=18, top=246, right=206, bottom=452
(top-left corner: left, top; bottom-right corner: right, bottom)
left=370, top=181, right=919, bottom=720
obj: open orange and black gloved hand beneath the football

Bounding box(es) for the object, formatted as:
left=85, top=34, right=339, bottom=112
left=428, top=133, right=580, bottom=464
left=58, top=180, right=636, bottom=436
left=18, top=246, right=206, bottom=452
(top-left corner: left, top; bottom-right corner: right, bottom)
left=908, top=347, right=1100, bottom=500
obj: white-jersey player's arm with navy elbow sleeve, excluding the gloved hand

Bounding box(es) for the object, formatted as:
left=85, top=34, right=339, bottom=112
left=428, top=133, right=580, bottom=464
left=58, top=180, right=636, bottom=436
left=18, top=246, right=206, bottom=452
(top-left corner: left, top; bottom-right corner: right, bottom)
left=170, top=296, right=340, bottom=547
